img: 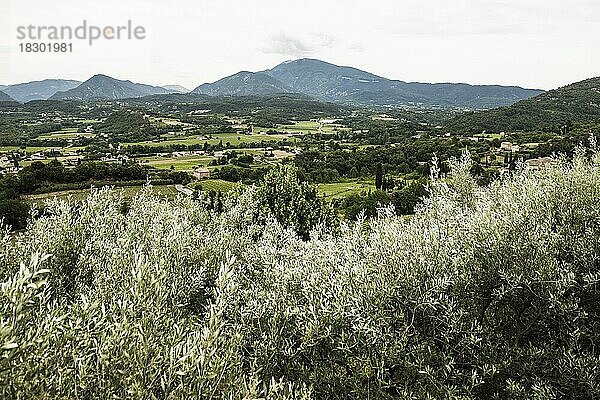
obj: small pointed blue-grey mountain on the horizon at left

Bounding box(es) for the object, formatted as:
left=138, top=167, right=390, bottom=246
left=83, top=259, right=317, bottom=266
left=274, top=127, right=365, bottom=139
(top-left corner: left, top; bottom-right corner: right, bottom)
left=50, top=74, right=172, bottom=101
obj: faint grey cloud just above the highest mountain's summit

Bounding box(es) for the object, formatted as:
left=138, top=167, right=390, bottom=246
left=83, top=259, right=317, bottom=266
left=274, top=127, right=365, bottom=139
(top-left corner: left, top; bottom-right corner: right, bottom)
left=261, top=31, right=337, bottom=57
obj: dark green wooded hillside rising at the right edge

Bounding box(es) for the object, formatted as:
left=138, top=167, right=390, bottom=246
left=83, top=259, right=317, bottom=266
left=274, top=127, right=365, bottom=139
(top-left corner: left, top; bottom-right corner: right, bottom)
left=445, top=77, right=600, bottom=133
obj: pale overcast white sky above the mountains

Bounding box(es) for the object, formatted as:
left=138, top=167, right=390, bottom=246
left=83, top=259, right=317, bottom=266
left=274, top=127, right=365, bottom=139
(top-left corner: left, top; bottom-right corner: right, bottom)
left=0, top=0, right=600, bottom=89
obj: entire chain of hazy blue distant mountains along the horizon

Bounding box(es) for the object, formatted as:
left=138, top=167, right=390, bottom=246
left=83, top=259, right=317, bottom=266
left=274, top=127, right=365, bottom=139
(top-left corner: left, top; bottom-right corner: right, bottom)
left=0, top=58, right=543, bottom=109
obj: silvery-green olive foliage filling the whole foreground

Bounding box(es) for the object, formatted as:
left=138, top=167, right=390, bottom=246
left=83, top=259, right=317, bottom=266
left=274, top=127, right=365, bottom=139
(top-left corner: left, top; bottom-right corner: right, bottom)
left=0, top=149, right=600, bottom=399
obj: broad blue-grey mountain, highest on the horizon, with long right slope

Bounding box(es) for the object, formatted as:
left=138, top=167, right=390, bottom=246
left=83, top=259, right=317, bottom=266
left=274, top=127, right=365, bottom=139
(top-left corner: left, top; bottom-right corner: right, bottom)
left=193, top=58, right=543, bottom=109
